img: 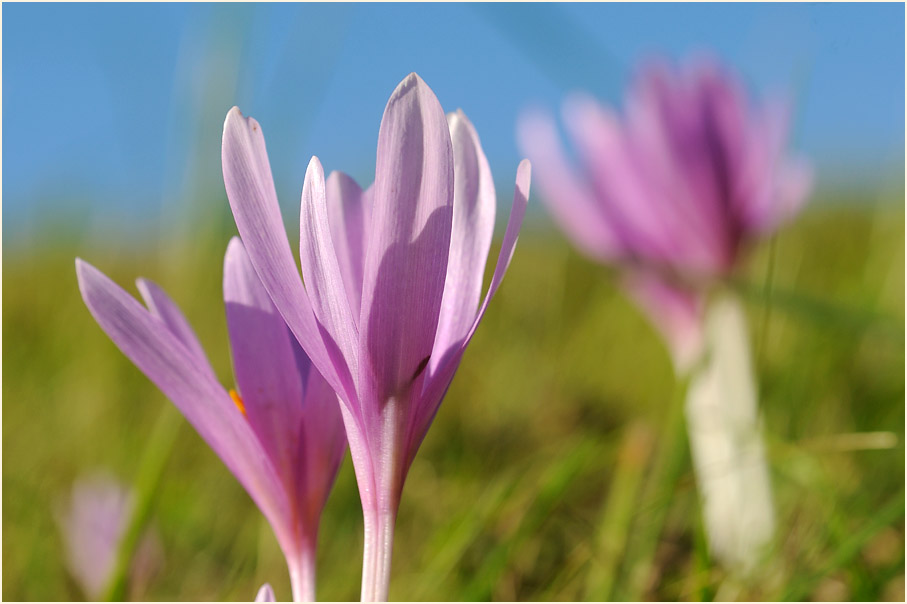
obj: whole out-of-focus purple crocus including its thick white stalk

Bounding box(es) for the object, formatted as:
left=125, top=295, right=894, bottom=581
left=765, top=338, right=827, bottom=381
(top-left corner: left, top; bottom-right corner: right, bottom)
left=518, top=60, right=811, bottom=566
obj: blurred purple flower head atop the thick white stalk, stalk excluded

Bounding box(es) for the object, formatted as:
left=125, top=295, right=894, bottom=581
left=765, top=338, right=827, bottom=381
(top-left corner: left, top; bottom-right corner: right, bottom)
left=518, top=60, right=811, bottom=371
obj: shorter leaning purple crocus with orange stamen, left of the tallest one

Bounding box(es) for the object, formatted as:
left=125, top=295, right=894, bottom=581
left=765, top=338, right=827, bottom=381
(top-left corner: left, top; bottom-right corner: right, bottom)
left=76, top=238, right=346, bottom=600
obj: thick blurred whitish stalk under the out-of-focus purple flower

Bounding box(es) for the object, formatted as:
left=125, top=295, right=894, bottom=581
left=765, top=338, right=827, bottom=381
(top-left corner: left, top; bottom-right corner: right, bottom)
left=686, top=294, right=775, bottom=573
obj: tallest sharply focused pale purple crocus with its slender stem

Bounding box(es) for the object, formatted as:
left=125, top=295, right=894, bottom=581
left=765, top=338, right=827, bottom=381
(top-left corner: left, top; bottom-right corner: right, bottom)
left=223, top=74, right=530, bottom=600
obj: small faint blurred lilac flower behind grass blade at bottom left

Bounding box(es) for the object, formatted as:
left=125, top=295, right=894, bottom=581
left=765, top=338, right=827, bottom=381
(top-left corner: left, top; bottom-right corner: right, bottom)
left=56, top=472, right=163, bottom=601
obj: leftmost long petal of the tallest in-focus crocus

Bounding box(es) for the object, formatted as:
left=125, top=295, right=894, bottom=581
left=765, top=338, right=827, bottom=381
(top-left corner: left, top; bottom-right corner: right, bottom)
left=221, top=107, right=356, bottom=408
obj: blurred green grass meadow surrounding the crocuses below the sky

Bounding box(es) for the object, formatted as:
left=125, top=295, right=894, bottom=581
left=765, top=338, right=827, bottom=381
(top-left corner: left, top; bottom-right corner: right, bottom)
left=2, top=197, right=905, bottom=600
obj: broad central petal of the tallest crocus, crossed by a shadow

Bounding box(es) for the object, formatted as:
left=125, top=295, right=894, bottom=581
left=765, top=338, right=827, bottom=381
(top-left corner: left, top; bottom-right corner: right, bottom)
left=359, top=74, right=453, bottom=405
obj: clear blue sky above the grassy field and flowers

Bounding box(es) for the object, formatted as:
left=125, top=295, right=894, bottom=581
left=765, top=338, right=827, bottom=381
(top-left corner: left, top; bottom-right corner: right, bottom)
left=2, top=4, right=904, bottom=234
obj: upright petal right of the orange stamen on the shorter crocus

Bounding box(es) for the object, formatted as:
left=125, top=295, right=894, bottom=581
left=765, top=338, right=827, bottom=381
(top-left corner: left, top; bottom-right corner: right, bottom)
left=224, top=237, right=303, bottom=485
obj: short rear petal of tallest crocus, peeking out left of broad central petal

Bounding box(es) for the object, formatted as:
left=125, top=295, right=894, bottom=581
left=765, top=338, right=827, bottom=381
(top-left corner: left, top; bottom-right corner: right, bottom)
left=325, top=172, right=371, bottom=318
